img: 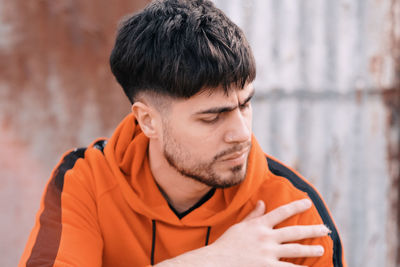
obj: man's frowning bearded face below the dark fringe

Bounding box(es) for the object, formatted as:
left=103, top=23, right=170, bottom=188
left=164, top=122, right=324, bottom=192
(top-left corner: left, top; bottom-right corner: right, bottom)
left=162, top=84, right=254, bottom=188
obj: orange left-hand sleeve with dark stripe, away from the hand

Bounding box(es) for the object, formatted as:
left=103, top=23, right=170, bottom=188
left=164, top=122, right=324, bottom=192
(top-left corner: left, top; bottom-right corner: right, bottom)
left=18, top=148, right=103, bottom=267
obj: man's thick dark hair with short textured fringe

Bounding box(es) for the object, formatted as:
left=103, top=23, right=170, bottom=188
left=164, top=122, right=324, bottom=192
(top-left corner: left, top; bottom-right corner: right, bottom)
left=110, top=0, right=256, bottom=103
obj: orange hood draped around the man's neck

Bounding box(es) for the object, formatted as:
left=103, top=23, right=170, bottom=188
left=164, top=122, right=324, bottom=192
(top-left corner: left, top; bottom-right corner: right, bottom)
left=104, top=114, right=269, bottom=227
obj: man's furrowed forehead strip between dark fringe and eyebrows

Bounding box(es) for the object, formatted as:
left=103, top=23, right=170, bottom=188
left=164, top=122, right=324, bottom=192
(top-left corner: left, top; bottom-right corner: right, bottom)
left=173, top=83, right=254, bottom=113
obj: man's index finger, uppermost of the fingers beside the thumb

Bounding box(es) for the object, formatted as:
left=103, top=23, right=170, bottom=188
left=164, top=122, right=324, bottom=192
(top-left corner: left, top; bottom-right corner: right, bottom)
left=265, top=198, right=311, bottom=227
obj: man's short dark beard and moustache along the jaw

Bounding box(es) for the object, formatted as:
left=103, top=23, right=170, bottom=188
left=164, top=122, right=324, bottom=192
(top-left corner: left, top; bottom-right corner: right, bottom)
left=163, top=123, right=251, bottom=188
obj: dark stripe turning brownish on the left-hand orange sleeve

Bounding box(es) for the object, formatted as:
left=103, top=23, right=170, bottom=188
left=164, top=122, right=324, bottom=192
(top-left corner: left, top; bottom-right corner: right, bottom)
left=26, top=148, right=86, bottom=267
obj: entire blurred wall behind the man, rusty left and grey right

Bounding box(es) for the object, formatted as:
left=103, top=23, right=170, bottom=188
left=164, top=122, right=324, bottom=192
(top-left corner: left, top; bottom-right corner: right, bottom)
left=0, top=0, right=400, bottom=267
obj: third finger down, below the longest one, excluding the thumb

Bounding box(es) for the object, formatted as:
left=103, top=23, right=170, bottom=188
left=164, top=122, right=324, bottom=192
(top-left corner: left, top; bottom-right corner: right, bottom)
left=277, top=244, right=324, bottom=258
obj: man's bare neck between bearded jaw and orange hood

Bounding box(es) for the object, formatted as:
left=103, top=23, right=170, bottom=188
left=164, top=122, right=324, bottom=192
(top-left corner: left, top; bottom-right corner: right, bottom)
left=148, top=140, right=211, bottom=212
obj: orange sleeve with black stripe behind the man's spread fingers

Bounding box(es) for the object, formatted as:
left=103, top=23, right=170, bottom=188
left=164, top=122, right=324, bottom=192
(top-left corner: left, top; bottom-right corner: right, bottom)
left=267, top=156, right=347, bottom=267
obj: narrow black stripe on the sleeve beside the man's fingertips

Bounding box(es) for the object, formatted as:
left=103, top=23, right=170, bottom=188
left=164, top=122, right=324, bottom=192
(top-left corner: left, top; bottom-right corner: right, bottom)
left=267, top=157, right=343, bottom=267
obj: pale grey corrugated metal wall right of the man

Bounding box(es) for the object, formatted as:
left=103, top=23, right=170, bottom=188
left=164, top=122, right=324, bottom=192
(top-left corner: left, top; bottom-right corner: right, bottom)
left=215, top=0, right=400, bottom=267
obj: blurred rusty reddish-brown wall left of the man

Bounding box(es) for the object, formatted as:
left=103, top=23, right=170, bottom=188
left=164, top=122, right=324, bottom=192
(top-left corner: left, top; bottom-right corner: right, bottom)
left=0, top=0, right=148, bottom=266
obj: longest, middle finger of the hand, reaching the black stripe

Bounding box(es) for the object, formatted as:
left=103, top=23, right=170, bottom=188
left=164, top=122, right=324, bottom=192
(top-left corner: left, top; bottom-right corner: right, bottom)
left=275, top=224, right=331, bottom=243
